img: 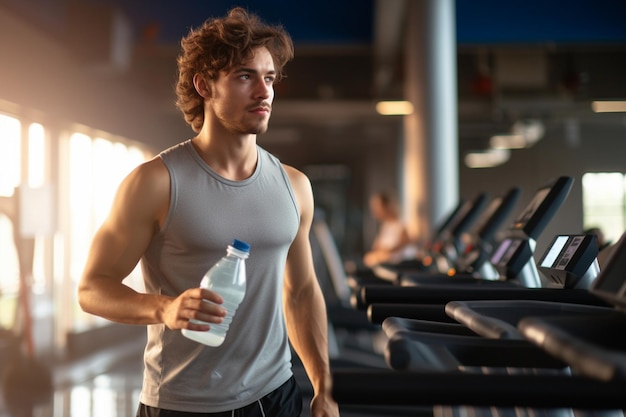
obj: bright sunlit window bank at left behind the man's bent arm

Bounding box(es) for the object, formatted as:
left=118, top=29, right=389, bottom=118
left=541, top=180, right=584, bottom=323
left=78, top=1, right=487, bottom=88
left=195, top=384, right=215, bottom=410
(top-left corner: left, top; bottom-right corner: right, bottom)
left=0, top=103, right=152, bottom=348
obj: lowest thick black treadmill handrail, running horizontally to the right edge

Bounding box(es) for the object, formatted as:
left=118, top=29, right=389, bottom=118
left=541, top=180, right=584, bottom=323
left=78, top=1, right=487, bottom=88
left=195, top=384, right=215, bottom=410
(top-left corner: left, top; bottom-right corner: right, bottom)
left=332, top=369, right=626, bottom=410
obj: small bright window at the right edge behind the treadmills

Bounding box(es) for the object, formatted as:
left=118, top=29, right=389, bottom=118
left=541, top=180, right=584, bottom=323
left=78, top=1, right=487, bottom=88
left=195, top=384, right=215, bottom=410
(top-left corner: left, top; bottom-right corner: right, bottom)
left=582, top=172, right=626, bottom=242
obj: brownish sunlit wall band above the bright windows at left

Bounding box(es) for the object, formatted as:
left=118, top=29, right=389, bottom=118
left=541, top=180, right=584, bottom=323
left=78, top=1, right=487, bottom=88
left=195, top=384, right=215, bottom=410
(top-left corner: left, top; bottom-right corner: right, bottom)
left=0, top=6, right=189, bottom=149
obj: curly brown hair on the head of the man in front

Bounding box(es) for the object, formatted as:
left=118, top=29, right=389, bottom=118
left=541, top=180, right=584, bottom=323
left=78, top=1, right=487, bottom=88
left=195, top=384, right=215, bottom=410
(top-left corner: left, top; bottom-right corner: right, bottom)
left=176, top=7, right=293, bottom=132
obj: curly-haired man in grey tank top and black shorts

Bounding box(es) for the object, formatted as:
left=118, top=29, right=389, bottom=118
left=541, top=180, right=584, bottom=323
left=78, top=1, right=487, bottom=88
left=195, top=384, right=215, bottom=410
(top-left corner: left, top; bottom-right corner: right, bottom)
left=79, top=8, right=339, bottom=417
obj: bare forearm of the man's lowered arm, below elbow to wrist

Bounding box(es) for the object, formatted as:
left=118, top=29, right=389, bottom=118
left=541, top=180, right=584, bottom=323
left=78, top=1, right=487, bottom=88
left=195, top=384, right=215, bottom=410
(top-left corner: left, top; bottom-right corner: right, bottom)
left=285, top=285, right=330, bottom=394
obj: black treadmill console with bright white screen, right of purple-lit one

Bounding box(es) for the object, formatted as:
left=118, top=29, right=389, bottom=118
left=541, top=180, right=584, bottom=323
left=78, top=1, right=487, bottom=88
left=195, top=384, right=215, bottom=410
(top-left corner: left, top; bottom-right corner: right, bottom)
left=538, top=234, right=598, bottom=288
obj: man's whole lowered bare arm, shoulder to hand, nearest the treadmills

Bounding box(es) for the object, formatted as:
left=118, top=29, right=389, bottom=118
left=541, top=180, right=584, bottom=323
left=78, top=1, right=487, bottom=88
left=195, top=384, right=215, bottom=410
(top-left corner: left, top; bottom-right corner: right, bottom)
left=283, top=167, right=339, bottom=417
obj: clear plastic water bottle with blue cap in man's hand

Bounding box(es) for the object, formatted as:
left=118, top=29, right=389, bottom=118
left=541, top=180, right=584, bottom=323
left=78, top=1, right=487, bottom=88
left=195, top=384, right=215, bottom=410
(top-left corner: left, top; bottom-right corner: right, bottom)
left=182, top=239, right=250, bottom=346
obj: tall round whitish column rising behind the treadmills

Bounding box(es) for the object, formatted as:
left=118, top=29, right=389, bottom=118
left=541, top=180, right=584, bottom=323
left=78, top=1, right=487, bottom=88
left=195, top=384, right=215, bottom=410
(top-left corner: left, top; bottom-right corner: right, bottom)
left=403, top=0, right=459, bottom=237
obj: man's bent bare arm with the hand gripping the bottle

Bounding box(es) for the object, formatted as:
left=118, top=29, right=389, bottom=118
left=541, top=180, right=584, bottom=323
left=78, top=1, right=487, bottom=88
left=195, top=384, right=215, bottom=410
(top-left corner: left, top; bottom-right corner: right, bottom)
left=78, top=158, right=224, bottom=330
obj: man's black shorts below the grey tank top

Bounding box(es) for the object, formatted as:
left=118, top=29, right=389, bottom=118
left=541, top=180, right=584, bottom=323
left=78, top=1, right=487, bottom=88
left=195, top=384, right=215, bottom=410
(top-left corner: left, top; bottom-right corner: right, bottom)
left=136, top=376, right=302, bottom=417
